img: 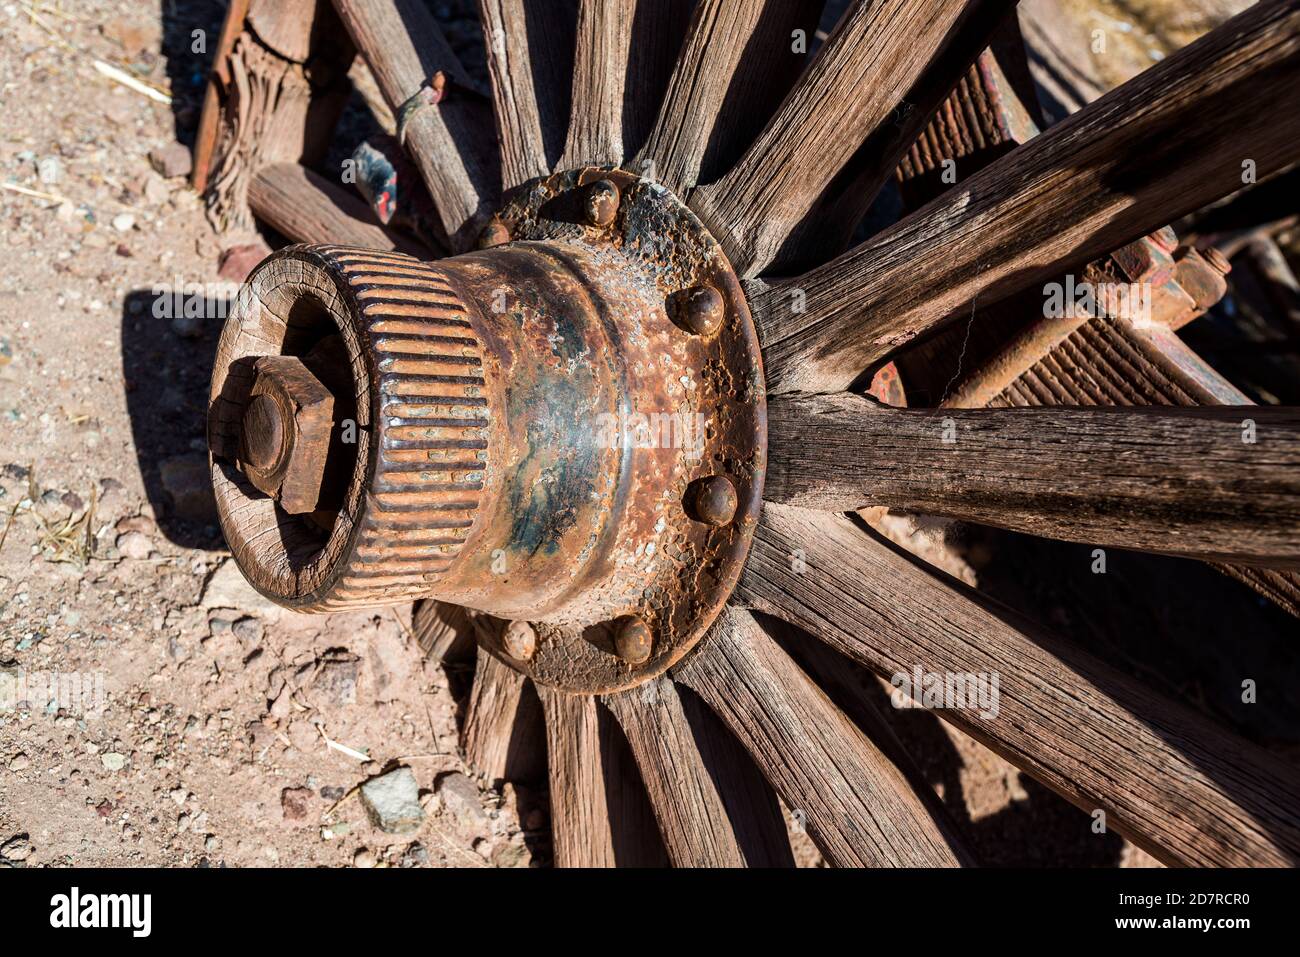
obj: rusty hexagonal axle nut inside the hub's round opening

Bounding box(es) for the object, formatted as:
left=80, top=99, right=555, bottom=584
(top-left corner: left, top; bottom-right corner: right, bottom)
left=239, top=355, right=334, bottom=515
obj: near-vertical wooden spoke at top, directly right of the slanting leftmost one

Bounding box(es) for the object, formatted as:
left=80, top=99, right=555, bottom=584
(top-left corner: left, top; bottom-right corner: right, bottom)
left=478, top=0, right=576, bottom=190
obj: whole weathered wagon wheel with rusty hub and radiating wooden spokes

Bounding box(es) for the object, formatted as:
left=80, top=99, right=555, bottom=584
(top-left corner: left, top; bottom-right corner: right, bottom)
left=200, top=0, right=1300, bottom=865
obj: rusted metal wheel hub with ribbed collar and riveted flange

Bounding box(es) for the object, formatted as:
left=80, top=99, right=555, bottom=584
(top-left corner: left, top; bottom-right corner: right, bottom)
left=211, top=169, right=766, bottom=692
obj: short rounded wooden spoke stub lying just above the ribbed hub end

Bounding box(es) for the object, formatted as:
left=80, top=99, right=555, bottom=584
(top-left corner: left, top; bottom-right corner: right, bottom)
left=248, top=163, right=429, bottom=256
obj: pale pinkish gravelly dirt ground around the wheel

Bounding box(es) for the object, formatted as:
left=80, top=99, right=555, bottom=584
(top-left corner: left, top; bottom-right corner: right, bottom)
left=0, top=0, right=1284, bottom=867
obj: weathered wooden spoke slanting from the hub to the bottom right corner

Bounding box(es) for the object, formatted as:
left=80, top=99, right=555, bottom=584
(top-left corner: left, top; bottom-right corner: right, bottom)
left=737, top=506, right=1300, bottom=866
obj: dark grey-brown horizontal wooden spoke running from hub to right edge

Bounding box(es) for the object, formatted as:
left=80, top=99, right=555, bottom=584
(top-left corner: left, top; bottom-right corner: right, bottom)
left=764, top=393, right=1300, bottom=566
